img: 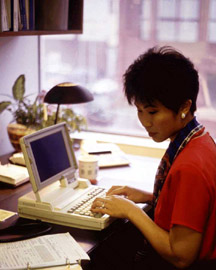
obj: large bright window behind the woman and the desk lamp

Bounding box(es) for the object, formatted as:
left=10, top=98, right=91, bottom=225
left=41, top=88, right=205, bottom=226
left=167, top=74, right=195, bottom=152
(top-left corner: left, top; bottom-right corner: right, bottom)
left=41, top=0, right=216, bottom=138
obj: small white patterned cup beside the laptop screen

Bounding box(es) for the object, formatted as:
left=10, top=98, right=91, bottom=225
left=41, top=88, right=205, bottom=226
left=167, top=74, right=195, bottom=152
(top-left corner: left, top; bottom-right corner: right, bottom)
left=78, top=155, right=98, bottom=180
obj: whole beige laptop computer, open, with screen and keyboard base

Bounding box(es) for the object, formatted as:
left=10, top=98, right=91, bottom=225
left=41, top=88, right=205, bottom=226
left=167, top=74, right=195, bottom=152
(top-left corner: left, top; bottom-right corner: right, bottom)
left=18, top=123, right=114, bottom=230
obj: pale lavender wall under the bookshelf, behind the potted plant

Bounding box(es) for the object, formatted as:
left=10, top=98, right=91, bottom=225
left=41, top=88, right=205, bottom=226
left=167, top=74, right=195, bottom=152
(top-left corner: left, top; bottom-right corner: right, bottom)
left=0, top=36, right=39, bottom=155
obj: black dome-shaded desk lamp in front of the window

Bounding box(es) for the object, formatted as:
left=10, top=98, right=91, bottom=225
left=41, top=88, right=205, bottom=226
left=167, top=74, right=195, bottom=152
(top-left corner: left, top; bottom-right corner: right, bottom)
left=44, top=82, right=94, bottom=124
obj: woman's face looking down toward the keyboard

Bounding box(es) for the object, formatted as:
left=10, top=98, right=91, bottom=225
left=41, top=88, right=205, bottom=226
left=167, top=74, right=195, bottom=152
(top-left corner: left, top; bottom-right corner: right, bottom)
left=135, top=101, right=184, bottom=142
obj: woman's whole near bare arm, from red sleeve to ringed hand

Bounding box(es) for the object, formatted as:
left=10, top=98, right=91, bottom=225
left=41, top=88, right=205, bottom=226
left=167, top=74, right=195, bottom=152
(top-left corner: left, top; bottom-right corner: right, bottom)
left=92, top=195, right=202, bottom=268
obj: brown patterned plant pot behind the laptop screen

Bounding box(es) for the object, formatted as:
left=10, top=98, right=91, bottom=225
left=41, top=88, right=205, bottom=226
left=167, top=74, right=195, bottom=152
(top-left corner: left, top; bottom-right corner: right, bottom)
left=7, top=123, right=35, bottom=152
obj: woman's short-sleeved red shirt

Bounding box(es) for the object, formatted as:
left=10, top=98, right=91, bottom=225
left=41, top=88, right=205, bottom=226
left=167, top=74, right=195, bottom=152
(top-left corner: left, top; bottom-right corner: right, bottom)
left=155, top=133, right=216, bottom=259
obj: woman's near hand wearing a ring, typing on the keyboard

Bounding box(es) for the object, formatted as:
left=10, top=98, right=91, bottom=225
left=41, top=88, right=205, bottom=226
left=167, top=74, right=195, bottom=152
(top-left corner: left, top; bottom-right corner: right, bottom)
left=91, top=195, right=138, bottom=218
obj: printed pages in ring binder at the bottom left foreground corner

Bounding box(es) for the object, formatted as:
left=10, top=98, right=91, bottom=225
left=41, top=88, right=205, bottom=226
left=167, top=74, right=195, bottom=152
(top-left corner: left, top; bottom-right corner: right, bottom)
left=0, top=233, right=90, bottom=270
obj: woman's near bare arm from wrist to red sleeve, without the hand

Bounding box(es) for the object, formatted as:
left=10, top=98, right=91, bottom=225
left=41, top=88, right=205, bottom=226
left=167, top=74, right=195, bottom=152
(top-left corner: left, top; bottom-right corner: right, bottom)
left=128, top=201, right=202, bottom=268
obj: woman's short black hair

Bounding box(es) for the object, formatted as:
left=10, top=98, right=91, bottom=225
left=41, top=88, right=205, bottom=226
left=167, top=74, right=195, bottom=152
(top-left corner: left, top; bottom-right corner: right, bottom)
left=123, top=46, right=199, bottom=115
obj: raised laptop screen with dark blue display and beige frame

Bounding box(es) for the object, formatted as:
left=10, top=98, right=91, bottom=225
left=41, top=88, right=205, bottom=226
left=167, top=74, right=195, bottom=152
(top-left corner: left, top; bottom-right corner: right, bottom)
left=20, top=123, right=77, bottom=192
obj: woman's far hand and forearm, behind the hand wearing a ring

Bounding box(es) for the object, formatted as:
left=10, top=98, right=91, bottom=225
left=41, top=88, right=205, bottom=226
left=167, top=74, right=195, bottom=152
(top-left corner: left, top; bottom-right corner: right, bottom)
left=107, top=186, right=153, bottom=203
